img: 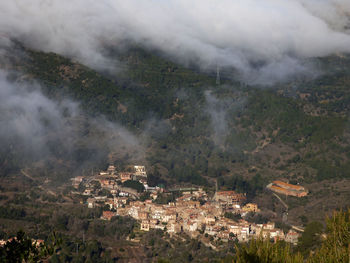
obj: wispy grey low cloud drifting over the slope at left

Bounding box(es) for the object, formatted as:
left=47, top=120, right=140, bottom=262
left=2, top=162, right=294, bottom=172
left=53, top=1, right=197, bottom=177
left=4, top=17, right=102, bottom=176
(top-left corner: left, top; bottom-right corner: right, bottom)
left=0, top=71, right=144, bottom=175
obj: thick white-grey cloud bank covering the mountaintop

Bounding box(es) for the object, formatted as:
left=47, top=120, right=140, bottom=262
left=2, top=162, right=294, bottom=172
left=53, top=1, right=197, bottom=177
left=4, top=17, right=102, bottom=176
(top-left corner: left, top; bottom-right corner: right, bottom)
left=0, top=0, right=350, bottom=84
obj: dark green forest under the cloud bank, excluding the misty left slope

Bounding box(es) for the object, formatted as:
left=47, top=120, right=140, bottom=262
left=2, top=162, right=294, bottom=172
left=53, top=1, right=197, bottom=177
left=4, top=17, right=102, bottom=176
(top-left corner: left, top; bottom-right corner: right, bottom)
left=2, top=43, right=350, bottom=188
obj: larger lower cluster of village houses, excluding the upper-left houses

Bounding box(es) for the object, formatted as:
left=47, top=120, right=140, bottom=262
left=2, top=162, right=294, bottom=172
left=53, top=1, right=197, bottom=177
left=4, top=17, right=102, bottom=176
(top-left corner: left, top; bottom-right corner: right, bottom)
left=101, top=189, right=299, bottom=244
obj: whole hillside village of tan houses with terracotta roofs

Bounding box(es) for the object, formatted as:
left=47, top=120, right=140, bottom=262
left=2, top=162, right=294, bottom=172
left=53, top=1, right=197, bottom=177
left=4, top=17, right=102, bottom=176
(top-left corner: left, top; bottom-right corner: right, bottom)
left=72, top=165, right=300, bottom=248
